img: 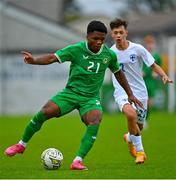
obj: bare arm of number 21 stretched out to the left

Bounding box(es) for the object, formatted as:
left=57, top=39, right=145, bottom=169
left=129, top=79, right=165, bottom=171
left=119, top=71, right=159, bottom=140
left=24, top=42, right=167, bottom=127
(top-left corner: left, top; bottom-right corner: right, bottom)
left=21, top=51, right=58, bottom=65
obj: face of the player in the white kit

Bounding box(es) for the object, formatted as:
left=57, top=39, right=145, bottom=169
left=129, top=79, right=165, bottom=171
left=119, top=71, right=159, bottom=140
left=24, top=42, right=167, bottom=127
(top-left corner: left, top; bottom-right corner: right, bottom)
left=111, top=26, right=128, bottom=44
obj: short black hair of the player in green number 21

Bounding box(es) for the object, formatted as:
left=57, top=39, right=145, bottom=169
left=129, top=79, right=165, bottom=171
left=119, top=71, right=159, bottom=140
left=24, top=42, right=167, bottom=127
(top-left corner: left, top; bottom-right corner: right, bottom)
left=87, top=20, right=107, bottom=34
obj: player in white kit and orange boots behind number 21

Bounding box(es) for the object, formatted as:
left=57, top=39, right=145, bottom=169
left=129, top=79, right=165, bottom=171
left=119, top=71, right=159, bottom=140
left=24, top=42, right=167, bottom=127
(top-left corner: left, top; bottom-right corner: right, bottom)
left=110, top=19, right=172, bottom=164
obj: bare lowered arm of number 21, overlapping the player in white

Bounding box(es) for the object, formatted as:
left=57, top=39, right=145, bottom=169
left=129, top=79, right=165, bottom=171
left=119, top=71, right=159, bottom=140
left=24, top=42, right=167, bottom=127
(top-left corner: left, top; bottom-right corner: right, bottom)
left=114, top=70, right=143, bottom=108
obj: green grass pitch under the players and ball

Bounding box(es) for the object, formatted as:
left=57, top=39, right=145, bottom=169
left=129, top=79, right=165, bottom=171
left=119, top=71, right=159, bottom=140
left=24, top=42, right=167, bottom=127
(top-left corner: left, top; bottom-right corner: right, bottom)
left=0, top=112, right=176, bottom=179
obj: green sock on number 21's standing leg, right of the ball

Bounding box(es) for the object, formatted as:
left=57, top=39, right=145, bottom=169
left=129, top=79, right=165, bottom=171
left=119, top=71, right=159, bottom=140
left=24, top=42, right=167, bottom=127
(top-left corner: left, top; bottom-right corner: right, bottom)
left=77, top=124, right=99, bottom=158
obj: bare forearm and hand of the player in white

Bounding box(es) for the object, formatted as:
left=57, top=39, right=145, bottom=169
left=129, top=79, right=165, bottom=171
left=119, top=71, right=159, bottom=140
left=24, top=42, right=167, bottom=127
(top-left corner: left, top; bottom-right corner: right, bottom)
left=151, top=63, right=173, bottom=84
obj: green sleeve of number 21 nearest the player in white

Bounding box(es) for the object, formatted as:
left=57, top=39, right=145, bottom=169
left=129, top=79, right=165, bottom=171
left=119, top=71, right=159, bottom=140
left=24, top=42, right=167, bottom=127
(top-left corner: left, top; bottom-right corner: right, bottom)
left=109, top=50, right=120, bottom=73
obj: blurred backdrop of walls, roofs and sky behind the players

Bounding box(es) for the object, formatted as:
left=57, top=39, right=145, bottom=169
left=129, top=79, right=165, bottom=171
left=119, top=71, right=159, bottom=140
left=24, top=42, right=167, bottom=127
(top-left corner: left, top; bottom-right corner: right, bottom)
left=0, top=0, right=176, bottom=115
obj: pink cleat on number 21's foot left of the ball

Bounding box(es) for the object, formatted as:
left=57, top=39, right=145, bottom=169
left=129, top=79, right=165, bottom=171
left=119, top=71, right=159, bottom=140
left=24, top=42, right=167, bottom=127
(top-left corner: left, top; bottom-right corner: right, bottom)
left=4, top=143, right=25, bottom=156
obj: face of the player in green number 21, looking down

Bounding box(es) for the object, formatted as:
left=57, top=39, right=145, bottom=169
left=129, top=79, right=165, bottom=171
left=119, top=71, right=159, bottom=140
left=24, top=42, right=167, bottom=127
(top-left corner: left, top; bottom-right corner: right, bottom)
left=87, top=31, right=106, bottom=53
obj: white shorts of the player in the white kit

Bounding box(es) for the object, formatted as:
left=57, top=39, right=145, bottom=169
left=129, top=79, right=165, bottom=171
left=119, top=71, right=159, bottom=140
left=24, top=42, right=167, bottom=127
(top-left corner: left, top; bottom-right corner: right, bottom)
left=114, top=96, right=148, bottom=124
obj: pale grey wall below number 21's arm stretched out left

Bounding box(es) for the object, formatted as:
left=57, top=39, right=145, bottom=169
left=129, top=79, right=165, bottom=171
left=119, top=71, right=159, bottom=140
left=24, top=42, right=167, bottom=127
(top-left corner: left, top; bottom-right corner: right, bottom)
left=0, top=55, right=69, bottom=114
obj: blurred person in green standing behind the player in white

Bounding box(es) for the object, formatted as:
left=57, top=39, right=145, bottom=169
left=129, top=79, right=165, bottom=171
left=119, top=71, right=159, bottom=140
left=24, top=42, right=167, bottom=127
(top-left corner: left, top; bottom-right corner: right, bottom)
left=143, top=35, right=162, bottom=119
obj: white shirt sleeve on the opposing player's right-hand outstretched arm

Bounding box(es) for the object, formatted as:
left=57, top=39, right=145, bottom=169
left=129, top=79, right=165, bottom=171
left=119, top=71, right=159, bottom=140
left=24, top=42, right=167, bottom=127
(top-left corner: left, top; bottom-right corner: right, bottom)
left=139, top=45, right=155, bottom=67
